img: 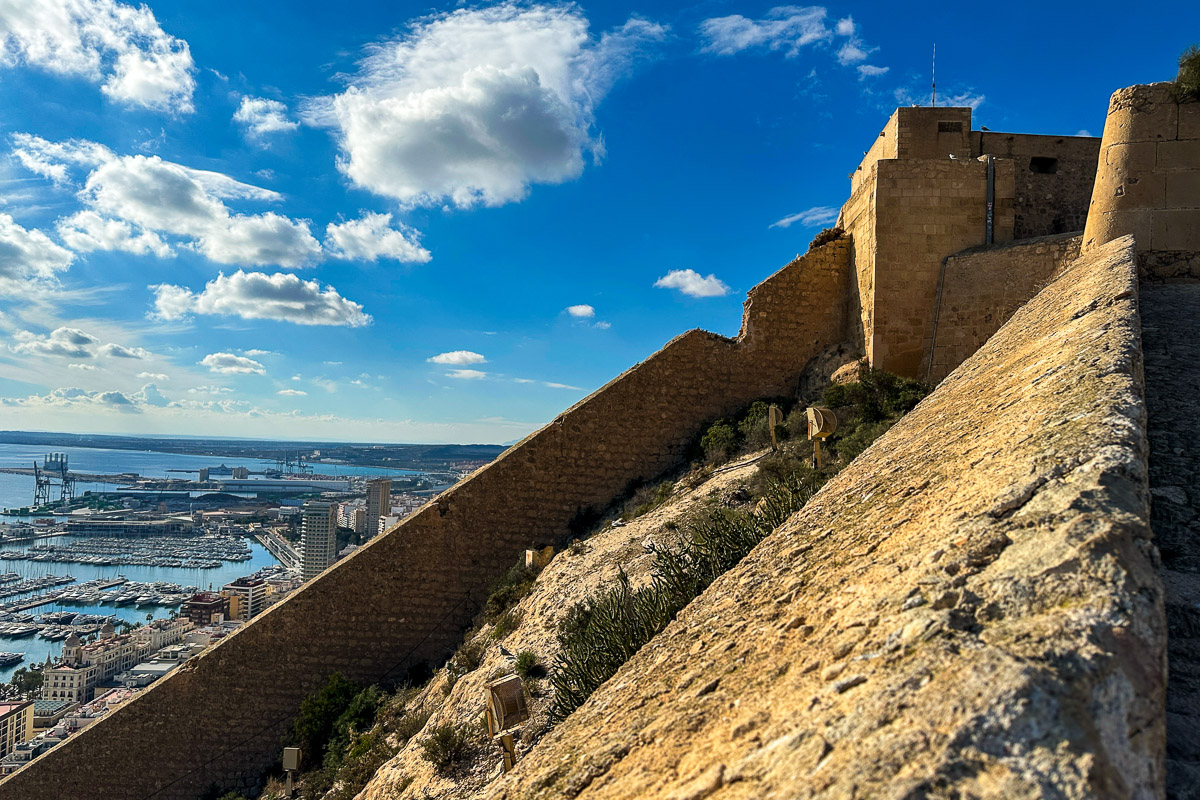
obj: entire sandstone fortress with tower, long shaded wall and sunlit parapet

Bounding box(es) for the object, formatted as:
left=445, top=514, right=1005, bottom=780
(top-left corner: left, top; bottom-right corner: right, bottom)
left=0, top=84, right=1200, bottom=800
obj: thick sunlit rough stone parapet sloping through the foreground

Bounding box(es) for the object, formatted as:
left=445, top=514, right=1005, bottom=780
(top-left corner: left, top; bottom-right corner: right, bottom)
left=484, top=237, right=1165, bottom=800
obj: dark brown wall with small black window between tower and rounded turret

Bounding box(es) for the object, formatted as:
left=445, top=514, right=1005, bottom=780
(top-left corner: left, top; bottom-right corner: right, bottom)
left=971, top=131, right=1100, bottom=239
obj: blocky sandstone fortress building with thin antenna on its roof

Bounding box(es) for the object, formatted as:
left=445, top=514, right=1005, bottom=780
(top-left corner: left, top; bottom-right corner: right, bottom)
left=838, top=107, right=1099, bottom=378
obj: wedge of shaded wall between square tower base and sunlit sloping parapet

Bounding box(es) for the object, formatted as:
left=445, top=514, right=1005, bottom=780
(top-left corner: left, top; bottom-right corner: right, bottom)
left=923, top=234, right=1082, bottom=384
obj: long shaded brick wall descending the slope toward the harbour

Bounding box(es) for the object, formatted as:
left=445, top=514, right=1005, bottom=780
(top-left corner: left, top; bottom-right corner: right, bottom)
left=0, top=240, right=850, bottom=800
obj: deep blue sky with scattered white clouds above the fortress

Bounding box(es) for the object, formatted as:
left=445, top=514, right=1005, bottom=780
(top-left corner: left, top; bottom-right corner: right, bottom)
left=0, top=0, right=1200, bottom=443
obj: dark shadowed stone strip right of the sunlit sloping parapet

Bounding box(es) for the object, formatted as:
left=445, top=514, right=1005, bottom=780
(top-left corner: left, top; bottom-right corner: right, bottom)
left=1141, top=283, right=1200, bottom=800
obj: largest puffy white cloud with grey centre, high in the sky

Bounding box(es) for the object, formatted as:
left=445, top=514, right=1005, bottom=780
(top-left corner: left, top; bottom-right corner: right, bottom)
left=306, top=2, right=666, bottom=206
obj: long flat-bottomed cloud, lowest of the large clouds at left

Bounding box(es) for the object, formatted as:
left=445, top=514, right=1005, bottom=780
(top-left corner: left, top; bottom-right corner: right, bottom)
left=150, top=270, right=371, bottom=327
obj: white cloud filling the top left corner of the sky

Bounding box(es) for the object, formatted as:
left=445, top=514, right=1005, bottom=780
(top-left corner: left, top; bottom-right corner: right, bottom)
left=0, top=0, right=196, bottom=113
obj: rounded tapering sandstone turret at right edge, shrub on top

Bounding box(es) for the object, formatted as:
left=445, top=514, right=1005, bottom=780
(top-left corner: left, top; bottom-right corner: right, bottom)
left=1084, top=83, right=1200, bottom=281
